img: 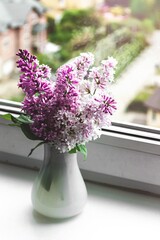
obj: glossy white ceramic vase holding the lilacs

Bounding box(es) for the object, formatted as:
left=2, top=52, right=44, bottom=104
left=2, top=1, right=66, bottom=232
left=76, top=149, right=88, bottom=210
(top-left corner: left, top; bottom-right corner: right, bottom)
left=31, top=144, right=87, bottom=218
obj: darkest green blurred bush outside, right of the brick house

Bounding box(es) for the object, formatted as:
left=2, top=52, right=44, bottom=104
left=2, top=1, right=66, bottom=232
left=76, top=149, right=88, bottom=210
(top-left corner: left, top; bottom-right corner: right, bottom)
left=43, top=9, right=101, bottom=70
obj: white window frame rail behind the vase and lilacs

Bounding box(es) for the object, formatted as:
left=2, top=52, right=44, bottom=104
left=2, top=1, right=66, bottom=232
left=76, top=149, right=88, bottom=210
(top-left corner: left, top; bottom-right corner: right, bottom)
left=0, top=99, right=160, bottom=194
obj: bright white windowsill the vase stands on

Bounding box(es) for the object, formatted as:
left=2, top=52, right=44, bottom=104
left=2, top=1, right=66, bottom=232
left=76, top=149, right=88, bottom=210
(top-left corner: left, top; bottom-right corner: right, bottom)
left=0, top=164, right=160, bottom=240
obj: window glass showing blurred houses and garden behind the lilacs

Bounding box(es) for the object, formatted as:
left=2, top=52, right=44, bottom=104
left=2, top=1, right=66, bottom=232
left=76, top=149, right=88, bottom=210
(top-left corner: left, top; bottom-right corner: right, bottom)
left=0, top=0, right=160, bottom=127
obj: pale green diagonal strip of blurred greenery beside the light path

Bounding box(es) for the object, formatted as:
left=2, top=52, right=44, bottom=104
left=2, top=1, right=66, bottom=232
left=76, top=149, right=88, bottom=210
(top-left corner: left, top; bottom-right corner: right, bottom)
left=86, top=27, right=147, bottom=78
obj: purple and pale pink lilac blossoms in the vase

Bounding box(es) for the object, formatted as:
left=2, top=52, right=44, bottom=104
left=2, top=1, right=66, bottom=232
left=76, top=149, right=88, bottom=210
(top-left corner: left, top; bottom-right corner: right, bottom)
left=17, top=50, right=117, bottom=152
